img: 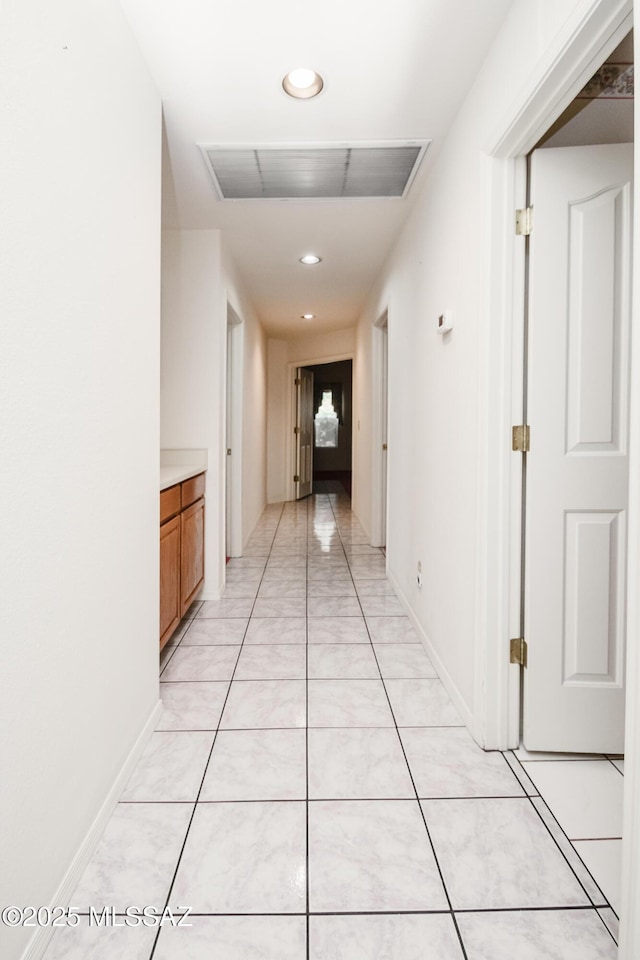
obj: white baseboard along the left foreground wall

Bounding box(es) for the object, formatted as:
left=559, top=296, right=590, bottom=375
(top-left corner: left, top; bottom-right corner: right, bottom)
left=21, top=700, right=162, bottom=960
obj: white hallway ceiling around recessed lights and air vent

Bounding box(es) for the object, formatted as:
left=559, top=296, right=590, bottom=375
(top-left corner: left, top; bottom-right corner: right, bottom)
left=121, top=0, right=511, bottom=339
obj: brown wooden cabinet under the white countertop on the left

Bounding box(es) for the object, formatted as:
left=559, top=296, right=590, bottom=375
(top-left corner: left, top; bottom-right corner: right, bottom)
left=160, top=473, right=205, bottom=649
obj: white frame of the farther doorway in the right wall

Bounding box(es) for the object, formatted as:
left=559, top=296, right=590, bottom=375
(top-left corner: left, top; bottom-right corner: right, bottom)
left=371, top=308, right=389, bottom=547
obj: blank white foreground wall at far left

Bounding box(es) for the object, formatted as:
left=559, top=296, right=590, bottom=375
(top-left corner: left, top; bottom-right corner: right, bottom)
left=0, top=0, right=161, bottom=960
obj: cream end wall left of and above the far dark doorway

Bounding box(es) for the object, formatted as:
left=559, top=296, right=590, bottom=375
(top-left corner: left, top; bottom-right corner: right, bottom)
left=267, top=327, right=356, bottom=503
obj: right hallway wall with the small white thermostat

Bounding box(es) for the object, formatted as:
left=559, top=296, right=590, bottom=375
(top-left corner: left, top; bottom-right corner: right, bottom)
left=354, top=0, right=624, bottom=722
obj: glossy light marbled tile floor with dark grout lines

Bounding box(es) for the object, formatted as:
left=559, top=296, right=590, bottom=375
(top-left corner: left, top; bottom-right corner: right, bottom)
left=46, top=485, right=622, bottom=960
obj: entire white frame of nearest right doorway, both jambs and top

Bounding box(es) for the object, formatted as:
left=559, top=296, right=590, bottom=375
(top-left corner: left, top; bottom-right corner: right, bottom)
left=472, top=0, right=640, bottom=944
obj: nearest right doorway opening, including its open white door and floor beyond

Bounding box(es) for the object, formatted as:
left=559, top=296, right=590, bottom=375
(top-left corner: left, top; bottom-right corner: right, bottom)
left=484, top=20, right=637, bottom=928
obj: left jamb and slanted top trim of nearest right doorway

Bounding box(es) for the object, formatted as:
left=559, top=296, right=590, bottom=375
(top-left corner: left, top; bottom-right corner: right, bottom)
left=473, top=0, right=633, bottom=750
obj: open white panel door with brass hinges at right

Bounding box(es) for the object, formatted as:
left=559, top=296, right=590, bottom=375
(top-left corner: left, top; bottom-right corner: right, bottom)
left=523, top=144, right=633, bottom=753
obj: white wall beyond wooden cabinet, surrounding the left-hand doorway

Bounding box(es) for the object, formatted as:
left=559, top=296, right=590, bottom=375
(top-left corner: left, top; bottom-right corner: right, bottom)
left=161, top=230, right=267, bottom=584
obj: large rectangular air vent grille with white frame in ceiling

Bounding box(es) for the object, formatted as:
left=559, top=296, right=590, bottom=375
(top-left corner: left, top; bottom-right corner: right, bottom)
left=199, top=140, right=431, bottom=200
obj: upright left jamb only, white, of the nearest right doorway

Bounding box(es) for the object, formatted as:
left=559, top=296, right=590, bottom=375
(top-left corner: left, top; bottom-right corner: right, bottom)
left=470, top=157, right=526, bottom=750
